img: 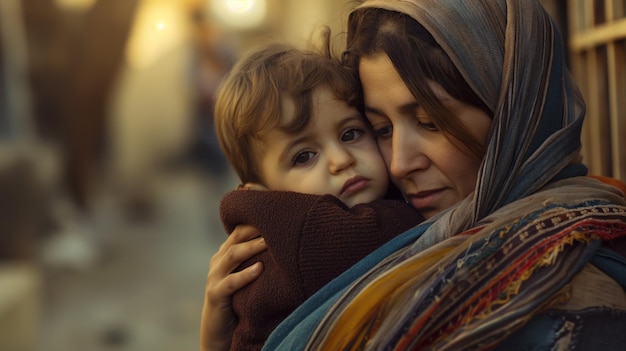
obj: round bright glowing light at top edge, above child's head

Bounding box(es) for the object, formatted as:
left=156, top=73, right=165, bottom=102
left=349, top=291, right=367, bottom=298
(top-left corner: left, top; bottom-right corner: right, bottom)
left=209, top=0, right=266, bottom=29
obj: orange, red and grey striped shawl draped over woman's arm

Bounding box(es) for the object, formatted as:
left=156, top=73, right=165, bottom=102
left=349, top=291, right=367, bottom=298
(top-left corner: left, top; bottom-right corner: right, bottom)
left=309, top=197, right=626, bottom=350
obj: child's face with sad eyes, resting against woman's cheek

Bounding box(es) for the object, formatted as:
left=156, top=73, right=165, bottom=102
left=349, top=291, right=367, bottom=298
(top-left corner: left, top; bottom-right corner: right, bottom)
left=261, top=87, right=389, bottom=206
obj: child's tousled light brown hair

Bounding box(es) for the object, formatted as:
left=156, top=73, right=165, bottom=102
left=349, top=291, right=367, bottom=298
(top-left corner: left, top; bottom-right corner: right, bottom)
left=214, top=43, right=360, bottom=184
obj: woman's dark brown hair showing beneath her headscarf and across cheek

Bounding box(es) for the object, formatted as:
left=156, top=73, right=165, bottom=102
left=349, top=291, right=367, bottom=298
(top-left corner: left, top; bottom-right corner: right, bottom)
left=342, top=8, right=493, bottom=159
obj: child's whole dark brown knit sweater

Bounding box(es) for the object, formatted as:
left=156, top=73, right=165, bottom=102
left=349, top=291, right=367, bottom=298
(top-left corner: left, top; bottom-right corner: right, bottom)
left=220, top=190, right=423, bottom=351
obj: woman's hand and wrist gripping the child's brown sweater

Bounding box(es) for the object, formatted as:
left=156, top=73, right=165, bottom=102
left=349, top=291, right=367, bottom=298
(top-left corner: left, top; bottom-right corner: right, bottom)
left=200, top=225, right=267, bottom=351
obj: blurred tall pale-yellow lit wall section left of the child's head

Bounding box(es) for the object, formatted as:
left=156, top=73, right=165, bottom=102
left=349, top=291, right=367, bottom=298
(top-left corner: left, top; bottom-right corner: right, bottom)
left=108, top=0, right=193, bottom=199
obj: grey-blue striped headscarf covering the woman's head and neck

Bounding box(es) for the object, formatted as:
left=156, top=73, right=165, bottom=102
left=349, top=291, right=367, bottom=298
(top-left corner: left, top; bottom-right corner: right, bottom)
left=361, top=0, right=586, bottom=241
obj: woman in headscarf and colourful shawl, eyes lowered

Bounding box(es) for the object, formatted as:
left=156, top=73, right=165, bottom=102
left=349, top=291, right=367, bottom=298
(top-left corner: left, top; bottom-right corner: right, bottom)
left=201, top=0, right=626, bottom=350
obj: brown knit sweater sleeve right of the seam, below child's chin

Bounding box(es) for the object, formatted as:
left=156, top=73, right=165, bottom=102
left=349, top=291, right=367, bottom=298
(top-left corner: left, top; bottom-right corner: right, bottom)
left=297, top=196, right=423, bottom=296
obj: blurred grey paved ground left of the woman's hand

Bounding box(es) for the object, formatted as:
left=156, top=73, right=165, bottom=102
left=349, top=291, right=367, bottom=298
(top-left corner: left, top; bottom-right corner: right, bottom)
left=38, top=172, right=234, bottom=351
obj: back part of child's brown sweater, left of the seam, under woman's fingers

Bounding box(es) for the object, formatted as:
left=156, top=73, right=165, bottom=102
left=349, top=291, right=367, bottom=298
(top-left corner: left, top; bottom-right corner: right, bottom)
left=220, top=190, right=319, bottom=351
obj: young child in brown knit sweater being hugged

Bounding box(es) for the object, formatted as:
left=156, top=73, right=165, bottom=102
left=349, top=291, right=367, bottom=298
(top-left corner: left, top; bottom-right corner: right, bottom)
left=210, top=44, right=422, bottom=350
